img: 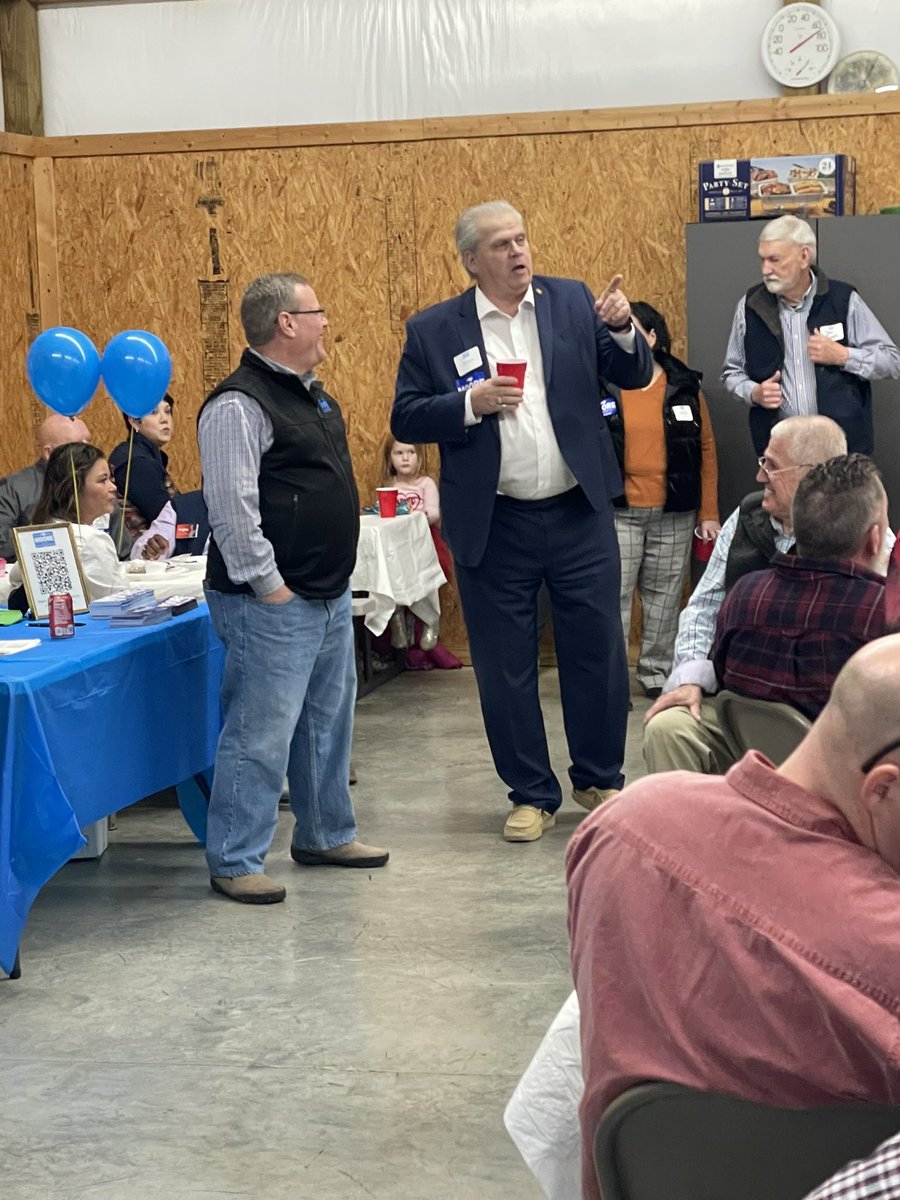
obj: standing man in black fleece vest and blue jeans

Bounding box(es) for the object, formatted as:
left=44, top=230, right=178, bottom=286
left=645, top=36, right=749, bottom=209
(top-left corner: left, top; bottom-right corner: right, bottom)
left=198, top=275, right=388, bottom=904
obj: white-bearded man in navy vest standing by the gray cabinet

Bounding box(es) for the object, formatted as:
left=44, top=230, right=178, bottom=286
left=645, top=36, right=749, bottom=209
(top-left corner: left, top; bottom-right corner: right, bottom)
left=722, top=216, right=900, bottom=455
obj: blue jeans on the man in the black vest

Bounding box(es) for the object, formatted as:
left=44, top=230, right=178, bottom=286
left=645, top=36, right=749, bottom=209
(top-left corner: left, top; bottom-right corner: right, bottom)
left=206, top=588, right=356, bottom=876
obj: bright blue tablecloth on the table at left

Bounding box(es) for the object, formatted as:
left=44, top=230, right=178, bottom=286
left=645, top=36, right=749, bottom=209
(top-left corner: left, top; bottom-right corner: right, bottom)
left=0, top=605, right=224, bottom=972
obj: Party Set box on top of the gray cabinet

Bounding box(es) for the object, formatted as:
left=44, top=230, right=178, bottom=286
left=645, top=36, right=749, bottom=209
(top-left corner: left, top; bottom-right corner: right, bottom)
left=698, top=154, right=856, bottom=221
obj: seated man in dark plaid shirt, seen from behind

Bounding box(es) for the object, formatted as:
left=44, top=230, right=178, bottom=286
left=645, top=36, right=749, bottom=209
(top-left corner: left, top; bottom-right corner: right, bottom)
left=713, top=454, right=888, bottom=720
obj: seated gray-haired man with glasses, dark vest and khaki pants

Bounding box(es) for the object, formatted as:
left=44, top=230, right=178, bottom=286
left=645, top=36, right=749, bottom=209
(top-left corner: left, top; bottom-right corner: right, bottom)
left=643, top=416, right=849, bottom=772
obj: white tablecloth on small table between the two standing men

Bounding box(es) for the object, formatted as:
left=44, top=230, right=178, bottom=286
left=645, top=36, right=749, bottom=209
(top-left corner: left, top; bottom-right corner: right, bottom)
left=350, top=512, right=446, bottom=636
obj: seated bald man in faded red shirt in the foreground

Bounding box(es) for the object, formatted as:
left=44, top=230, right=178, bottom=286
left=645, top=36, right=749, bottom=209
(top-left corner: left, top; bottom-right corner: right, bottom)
left=566, top=635, right=900, bottom=1200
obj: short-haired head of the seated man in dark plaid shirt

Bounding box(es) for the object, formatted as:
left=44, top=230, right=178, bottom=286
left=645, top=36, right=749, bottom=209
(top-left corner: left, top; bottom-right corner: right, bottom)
left=793, top=454, right=884, bottom=562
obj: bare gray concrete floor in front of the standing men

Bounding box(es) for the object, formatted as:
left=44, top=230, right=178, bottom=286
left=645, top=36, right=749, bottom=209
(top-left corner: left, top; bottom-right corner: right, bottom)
left=0, top=670, right=647, bottom=1200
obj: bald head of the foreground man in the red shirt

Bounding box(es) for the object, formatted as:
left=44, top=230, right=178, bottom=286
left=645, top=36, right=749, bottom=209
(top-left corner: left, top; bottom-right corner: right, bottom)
left=780, top=634, right=900, bottom=871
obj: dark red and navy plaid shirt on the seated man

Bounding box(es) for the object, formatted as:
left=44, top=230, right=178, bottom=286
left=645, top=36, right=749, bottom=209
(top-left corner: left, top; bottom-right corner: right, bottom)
left=713, top=552, right=884, bottom=719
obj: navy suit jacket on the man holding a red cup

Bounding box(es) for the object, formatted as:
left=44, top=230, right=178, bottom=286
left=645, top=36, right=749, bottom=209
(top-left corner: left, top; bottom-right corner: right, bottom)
left=391, top=275, right=653, bottom=566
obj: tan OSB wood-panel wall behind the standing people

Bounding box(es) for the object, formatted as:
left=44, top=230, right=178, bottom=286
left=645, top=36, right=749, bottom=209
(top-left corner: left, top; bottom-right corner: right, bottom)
left=0, top=97, right=900, bottom=647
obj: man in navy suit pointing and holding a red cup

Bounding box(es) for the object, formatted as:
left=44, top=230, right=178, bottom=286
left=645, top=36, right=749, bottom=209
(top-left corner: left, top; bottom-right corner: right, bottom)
left=391, top=200, right=653, bottom=841
